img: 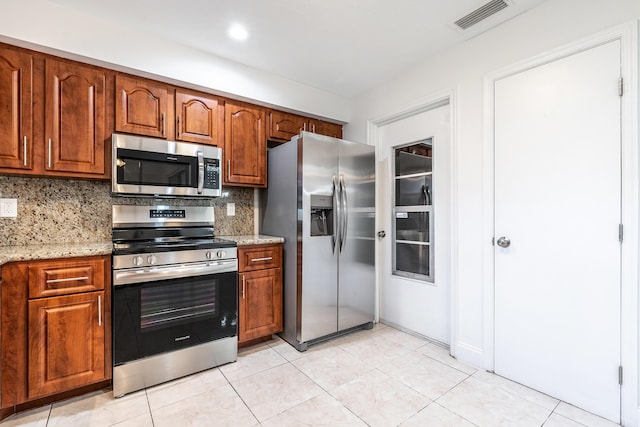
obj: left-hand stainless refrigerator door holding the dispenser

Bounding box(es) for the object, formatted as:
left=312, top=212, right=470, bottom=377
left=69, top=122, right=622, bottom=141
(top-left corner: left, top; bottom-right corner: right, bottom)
left=297, top=132, right=341, bottom=342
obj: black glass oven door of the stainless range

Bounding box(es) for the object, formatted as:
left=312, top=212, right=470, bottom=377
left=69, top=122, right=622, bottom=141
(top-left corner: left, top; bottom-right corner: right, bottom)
left=113, top=267, right=238, bottom=366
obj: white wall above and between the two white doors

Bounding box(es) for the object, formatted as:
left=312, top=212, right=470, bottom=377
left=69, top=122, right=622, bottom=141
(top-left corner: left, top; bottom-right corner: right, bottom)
left=344, top=0, right=640, bottom=374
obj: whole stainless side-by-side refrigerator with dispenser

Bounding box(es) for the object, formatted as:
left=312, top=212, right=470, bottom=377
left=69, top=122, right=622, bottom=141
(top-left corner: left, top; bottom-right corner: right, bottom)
left=261, top=132, right=375, bottom=351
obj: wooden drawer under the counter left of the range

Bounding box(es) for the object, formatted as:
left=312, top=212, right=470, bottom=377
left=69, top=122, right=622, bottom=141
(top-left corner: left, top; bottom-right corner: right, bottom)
left=28, top=258, right=107, bottom=298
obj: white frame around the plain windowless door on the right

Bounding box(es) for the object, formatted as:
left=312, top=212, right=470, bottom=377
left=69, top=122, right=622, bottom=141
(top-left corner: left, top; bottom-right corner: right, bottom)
left=482, top=21, right=640, bottom=426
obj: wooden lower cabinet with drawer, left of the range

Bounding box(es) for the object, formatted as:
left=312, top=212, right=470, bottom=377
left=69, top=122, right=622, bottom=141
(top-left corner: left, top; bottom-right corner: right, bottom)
left=0, top=255, right=111, bottom=415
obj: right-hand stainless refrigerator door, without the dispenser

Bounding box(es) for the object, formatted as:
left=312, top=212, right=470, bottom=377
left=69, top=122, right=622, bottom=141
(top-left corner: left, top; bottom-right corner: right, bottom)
left=338, top=140, right=375, bottom=330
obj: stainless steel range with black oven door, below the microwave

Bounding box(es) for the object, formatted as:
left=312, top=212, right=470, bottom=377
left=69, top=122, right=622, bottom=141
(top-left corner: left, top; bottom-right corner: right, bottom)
left=113, top=206, right=238, bottom=397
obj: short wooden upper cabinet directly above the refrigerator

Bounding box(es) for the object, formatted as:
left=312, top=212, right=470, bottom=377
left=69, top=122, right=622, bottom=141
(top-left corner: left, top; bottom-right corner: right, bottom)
left=268, top=110, right=342, bottom=142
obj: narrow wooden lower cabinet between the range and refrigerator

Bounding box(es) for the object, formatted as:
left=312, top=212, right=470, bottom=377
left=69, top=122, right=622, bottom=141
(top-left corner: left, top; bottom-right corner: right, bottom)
left=238, top=245, right=282, bottom=343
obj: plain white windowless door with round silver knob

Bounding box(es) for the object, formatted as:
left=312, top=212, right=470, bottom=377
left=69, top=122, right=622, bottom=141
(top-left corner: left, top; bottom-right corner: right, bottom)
left=495, top=41, right=621, bottom=422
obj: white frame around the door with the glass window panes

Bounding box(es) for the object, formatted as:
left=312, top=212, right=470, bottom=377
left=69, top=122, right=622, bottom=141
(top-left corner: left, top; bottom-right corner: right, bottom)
left=367, top=88, right=459, bottom=355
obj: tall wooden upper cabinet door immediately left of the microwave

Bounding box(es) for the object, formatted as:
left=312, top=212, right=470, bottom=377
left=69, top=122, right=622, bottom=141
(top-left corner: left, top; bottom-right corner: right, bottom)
left=45, top=59, right=107, bottom=176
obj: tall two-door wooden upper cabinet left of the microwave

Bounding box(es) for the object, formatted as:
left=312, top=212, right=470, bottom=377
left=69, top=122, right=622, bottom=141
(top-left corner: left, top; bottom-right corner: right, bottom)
left=0, top=45, right=111, bottom=178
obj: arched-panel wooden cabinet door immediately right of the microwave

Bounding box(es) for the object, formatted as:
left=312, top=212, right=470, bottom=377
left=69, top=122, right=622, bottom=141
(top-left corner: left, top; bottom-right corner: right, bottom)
left=222, top=101, right=267, bottom=187
